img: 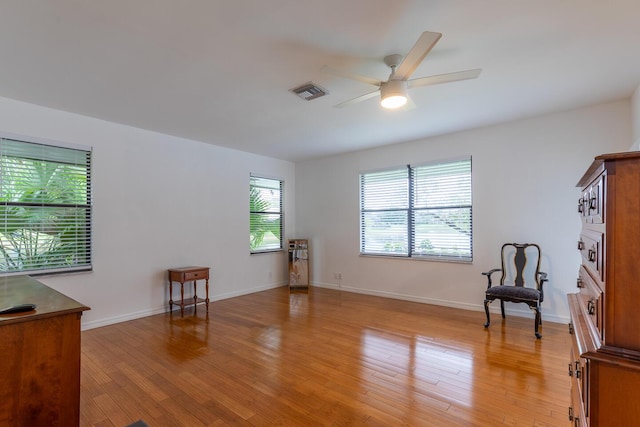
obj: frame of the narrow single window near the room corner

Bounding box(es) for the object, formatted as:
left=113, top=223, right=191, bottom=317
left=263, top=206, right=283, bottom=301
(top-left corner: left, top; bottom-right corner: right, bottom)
left=249, top=174, right=285, bottom=255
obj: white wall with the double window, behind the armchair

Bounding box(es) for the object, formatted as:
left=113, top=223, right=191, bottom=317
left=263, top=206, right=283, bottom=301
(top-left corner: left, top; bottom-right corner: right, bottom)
left=296, top=100, right=631, bottom=321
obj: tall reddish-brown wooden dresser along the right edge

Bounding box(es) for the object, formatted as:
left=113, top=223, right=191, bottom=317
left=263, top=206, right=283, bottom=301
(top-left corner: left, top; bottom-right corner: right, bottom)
left=568, top=152, right=640, bottom=427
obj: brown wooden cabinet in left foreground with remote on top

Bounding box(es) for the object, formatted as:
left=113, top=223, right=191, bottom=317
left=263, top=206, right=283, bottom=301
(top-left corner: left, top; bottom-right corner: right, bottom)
left=0, top=276, right=89, bottom=427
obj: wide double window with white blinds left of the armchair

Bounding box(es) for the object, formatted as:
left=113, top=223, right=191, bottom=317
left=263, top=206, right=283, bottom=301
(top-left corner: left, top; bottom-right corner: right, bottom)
left=360, top=157, right=473, bottom=261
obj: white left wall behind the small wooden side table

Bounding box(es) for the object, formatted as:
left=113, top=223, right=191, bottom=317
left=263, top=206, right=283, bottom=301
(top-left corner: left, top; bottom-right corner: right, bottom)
left=0, top=98, right=295, bottom=329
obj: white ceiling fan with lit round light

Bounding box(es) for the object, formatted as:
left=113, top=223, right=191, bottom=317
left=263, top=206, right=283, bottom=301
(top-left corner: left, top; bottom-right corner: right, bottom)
left=323, top=31, right=482, bottom=108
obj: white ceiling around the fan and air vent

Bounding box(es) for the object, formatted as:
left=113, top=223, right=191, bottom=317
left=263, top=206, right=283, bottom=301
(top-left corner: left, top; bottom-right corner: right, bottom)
left=0, top=0, right=640, bottom=161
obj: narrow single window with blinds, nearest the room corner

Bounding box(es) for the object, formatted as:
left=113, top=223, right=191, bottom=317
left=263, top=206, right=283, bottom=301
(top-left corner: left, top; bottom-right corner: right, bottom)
left=249, top=176, right=284, bottom=253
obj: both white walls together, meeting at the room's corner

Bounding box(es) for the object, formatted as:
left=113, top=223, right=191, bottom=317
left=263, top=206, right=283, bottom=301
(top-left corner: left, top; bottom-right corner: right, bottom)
left=0, top=94, right=640, bottom=329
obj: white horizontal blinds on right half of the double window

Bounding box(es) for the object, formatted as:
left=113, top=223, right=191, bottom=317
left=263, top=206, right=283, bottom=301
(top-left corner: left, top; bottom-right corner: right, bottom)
left=412, top=158, right=472, bottom=261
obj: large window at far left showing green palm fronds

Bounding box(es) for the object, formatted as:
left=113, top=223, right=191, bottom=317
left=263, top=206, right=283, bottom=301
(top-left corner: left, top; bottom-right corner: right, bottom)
left=0, top=136, right=91, bottom=275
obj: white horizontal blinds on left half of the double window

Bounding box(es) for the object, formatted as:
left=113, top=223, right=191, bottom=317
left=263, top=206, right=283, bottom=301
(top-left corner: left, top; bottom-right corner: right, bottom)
left=360, top=168, right=409, bottom=256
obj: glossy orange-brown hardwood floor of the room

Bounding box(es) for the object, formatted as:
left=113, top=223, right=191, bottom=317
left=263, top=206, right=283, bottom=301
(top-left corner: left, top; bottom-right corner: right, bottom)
left=80, top=287, right=570, bottom=427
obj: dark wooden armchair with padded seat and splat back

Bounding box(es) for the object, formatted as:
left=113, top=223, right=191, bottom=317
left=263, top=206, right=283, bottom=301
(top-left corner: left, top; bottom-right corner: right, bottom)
left=482, top=243, right=548, bottom=338
